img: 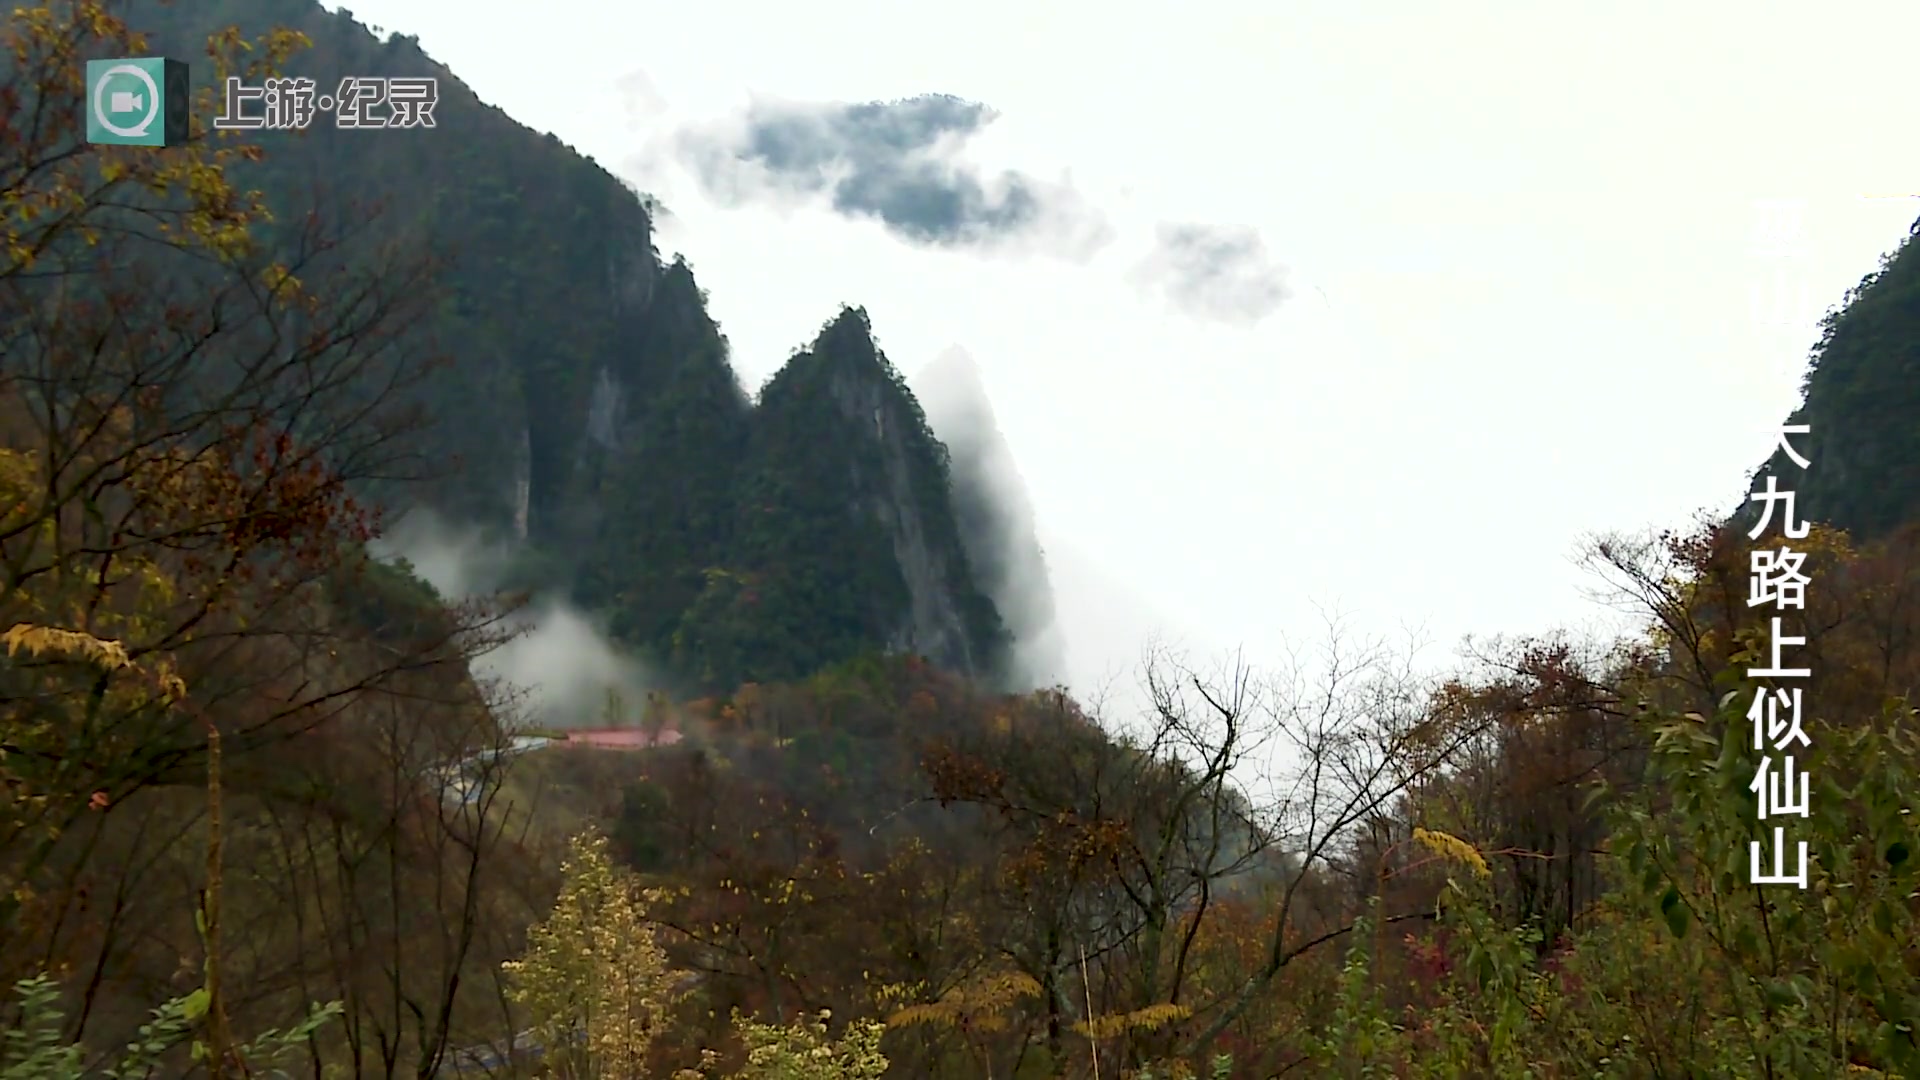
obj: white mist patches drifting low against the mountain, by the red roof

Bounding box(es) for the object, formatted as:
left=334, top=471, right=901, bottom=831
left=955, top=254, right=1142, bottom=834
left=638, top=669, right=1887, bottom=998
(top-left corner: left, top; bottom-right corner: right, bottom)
left=372, top=509, right=655, bottom=726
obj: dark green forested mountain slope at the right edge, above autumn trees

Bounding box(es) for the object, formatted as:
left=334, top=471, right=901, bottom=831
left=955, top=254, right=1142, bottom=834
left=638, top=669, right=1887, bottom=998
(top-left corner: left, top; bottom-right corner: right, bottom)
left=1736, top=221, right=1920, bottom=540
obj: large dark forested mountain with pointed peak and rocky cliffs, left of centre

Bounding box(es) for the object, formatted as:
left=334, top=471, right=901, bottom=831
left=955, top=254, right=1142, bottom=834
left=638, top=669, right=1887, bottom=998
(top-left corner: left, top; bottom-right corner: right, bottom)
left=129, top=0, right=1029, bottom=692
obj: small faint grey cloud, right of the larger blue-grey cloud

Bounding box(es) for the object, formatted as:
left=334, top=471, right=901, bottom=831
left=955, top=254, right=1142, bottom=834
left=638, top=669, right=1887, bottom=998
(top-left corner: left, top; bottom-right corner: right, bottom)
left=1133, top=225, right=1292, bottom=325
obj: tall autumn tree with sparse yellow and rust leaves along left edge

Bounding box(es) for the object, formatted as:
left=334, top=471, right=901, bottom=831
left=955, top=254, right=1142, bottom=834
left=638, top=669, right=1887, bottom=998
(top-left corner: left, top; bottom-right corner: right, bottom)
left=0, top=0, right=526, bottom=1060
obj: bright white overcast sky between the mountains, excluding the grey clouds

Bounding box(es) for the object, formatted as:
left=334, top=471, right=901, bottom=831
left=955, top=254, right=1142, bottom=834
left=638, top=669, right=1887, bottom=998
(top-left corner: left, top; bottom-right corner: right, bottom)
left=326, top=0, right=1920, bottom=699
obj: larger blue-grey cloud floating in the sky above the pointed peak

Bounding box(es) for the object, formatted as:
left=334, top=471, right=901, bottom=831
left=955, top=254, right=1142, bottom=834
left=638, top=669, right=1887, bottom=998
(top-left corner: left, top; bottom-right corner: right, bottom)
left=678, top=94, right=1112, bottom=258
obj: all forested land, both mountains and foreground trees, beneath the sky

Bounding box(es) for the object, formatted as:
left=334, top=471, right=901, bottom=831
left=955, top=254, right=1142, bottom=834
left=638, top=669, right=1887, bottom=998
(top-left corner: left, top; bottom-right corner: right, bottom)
left=0, top=0, right=1920, bottom=1080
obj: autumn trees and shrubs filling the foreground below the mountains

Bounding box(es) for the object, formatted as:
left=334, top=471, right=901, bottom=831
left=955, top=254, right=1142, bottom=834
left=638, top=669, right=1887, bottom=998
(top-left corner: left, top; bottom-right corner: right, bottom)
left=0, top=2, right=1920, bottom=1080
